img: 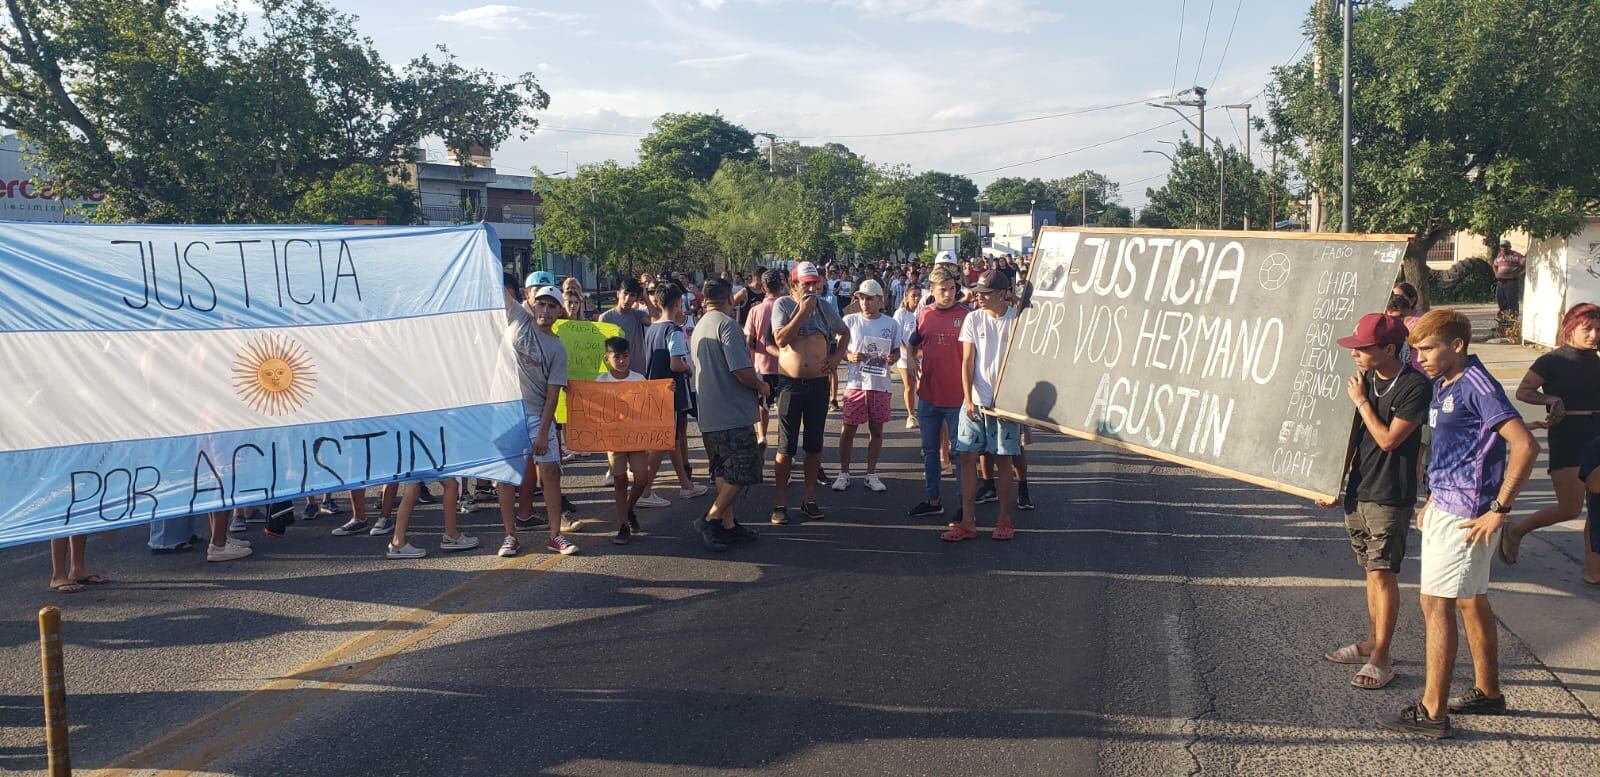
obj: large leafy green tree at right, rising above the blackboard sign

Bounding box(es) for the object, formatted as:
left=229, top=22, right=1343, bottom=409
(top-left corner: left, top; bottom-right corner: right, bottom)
left=1270, top=0, right=1600, bottom=300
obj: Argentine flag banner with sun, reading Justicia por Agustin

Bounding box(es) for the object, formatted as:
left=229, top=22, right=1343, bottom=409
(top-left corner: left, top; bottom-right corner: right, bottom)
left=0, top=222, right=530, bottom=547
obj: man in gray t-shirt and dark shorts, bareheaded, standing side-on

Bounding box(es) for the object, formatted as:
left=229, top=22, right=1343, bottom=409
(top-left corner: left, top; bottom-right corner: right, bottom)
left=690, top=278, right=768, bottom=552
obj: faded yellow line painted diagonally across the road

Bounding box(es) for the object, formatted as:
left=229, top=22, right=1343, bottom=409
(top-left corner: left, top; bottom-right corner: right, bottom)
left=93, top=555, right=565, bottom=777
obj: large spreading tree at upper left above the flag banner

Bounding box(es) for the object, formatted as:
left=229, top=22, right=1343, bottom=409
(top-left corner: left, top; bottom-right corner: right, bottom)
left=0, top=0, right=549, bottom=222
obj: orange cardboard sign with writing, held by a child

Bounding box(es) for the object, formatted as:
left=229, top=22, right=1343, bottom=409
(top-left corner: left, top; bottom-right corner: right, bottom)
left=566, top=381, right=677, bottom=452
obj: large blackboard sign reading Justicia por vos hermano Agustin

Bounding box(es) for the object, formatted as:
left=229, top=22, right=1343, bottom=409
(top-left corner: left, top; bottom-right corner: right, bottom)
left=995, top=227, right=1406, bottom=499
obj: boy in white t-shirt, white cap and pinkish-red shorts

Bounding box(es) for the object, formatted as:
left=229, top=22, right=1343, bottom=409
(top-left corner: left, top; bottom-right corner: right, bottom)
left=834, top=280, right=904, bottom=492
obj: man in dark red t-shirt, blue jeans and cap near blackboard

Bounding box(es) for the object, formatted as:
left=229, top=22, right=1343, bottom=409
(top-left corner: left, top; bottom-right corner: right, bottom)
left=906, top=264, right=968, bottom=521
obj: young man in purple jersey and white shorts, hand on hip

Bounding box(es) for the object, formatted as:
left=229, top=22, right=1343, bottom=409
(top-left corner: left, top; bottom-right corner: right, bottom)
left=1378, top=309, right=1539, bottom=739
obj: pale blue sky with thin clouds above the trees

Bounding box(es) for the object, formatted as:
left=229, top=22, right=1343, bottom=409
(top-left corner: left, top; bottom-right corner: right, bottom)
left=275, top=0, right=1310, bottom=205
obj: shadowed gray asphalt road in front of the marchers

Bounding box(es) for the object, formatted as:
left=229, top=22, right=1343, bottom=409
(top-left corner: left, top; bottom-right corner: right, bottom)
left=0, top=401, right=1600, bottom=777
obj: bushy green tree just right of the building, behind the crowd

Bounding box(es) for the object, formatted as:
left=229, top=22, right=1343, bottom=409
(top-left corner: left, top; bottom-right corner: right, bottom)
left=534, top=160, right=698, bottom=275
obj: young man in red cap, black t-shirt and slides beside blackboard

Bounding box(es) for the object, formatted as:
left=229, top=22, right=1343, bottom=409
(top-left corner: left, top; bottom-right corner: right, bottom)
left=1318, top=313, right=1434, bottom=691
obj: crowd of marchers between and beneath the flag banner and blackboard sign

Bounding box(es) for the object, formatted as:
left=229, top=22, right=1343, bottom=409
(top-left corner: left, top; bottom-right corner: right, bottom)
left=51, top=251, right=1034, bottom=593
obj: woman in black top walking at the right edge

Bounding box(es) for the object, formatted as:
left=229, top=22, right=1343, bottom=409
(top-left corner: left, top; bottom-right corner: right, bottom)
left=1499, top=302, right=1600, bottom=564
